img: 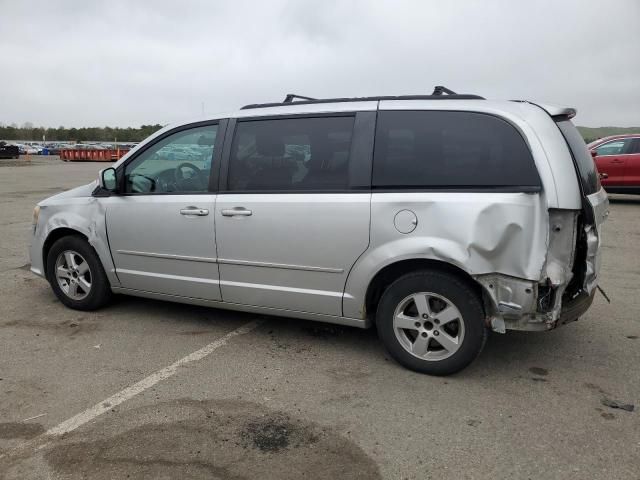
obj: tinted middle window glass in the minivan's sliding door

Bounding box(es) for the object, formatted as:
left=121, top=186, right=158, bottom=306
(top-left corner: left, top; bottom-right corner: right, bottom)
left=228, top=117, right=354, bottom=191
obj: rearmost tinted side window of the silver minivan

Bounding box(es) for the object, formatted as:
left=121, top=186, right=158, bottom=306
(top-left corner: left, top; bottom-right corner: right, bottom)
left=373, top=111, right=540, bottom=191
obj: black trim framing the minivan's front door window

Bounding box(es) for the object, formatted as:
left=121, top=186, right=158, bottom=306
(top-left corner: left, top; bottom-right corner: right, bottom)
left=116, top=118, right=228, bottom=197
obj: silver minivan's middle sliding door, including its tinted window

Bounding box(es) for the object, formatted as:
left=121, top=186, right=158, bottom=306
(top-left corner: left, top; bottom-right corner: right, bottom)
left=216, top=115, right=374, bottom=315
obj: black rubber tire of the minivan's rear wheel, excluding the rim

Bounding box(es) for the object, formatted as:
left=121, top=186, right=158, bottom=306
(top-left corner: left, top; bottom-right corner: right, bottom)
left=376, top=270, right=488, bottom=375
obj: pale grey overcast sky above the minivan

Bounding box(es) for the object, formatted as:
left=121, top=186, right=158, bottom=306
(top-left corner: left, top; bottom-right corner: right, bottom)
left=0, top=0, right=640, bottom=127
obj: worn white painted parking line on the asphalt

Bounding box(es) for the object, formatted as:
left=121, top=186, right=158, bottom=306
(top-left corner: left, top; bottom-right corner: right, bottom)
left=0, top=320, right=263, bottom=458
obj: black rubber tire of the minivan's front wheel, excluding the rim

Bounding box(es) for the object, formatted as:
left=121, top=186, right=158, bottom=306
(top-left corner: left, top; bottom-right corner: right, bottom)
left=47, top=235, right=113, bottom=310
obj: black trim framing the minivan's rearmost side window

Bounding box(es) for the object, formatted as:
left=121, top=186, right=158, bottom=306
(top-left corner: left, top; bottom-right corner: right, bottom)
left=371, top=109, right=543, bottom=194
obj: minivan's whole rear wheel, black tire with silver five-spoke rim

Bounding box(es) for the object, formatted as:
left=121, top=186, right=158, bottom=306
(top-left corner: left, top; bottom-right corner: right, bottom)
left=376, top=271, right=487, bottom=375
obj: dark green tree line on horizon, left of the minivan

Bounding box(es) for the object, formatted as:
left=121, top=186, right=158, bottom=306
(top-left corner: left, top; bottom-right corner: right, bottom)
left=0, top=122, right=162, bottom=143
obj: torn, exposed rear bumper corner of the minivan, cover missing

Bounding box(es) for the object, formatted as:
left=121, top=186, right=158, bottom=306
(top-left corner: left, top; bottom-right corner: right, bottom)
left=474, top=189, right=609, bottom=333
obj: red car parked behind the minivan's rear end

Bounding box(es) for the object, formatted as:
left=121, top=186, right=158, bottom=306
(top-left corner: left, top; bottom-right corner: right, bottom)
left=587, top=133, right=640, bottom=194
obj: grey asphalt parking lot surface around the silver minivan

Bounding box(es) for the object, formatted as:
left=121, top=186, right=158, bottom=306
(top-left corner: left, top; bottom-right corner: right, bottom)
left=0, top=157, right=640, bottom=480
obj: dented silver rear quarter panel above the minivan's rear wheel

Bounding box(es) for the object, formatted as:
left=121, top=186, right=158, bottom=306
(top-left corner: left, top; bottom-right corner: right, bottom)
left=343, top=192, right=548, bottom=318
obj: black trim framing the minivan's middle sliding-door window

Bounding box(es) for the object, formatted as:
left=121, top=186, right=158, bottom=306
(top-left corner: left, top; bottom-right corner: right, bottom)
left=217, top=110, right=377, bottom=195
